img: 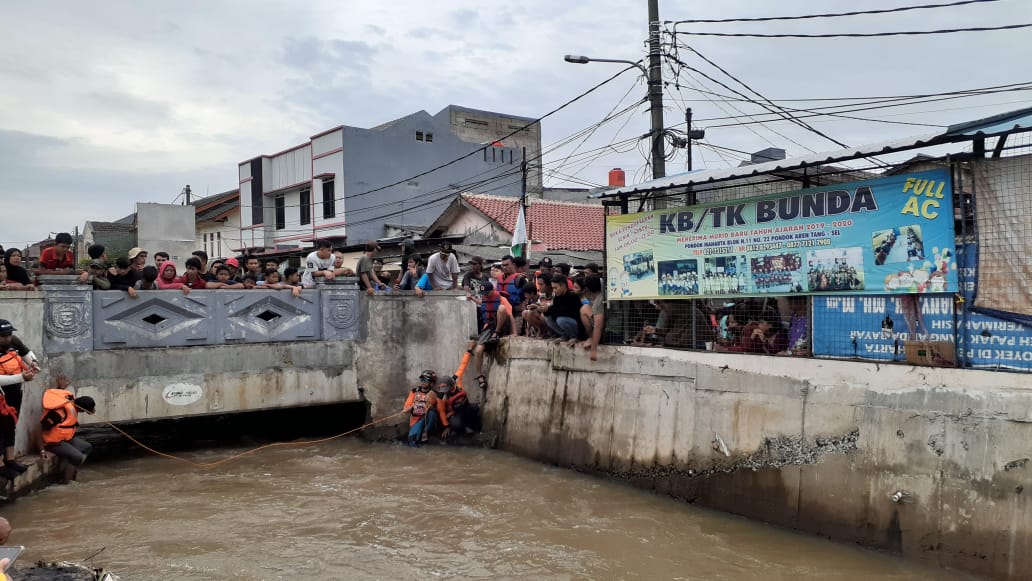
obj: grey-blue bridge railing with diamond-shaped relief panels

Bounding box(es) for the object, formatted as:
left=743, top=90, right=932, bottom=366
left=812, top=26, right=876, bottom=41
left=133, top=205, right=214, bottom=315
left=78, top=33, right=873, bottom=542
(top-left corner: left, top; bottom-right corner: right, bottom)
left=43, top=279, right=367, bottom=353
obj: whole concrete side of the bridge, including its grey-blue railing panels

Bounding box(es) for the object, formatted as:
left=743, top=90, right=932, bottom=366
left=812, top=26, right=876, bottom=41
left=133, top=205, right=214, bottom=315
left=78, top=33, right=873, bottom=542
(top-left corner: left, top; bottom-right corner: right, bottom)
left=0, top=288, right=476, bottom=496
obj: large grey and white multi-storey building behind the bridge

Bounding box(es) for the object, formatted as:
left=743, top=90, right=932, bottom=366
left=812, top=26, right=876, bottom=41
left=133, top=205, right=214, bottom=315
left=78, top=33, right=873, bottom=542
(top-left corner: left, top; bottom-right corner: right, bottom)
left=238, top=105, right=541, bottom=252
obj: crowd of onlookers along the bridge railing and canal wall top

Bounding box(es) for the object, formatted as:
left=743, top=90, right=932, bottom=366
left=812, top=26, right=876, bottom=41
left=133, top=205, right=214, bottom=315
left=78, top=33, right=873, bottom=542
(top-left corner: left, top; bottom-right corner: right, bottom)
left=0, top=234, right=809, bottom=365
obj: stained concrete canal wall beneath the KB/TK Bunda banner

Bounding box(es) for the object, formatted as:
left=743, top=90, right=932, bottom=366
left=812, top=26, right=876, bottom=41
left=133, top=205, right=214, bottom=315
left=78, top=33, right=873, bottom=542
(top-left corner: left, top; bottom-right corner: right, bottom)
left=486, top=338, right=1032, bottom=579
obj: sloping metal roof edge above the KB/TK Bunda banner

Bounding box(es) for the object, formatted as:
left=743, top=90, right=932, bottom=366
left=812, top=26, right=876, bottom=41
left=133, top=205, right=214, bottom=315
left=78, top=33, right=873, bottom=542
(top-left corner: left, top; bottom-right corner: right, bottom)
left=592, top=107, right=1032, bottom=197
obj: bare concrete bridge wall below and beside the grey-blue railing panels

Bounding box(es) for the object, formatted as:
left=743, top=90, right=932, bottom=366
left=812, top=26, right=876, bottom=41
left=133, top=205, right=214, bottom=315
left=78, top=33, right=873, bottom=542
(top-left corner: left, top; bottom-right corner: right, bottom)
left=0, top=291, right=476, bottom=441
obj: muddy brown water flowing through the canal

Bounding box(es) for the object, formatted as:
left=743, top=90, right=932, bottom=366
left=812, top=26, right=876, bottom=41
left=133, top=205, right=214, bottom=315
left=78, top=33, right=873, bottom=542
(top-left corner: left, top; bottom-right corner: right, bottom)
left=2, top=440, right=972, bottom=581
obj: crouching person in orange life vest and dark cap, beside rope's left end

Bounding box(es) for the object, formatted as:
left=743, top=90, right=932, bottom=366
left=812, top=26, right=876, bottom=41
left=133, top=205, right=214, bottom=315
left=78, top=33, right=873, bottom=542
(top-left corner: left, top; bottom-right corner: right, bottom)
left=39, top=376, right=97, bottom=484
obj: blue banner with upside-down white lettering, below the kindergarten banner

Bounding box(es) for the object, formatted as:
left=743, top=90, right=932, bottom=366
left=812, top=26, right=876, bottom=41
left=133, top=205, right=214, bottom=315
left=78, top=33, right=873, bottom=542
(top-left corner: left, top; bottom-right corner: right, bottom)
left=812, top=245, right=1032, bottom=370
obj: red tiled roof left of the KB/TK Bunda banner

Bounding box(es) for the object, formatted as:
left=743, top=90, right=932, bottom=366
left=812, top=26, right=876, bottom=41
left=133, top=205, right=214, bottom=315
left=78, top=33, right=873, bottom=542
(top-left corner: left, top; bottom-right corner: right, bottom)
left=462, top=194, right=606, bottom=250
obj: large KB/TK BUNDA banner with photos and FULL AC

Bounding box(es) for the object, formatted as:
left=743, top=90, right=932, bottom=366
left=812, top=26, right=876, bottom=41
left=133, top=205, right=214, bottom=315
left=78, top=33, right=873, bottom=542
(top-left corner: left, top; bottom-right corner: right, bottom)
left=606, top=169, right=958, bottom=300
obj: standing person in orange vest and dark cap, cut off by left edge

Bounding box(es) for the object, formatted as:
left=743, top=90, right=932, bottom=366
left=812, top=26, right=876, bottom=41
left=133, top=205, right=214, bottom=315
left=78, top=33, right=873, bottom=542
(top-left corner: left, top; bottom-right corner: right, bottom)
left=0, top=319, right=39, bottom=480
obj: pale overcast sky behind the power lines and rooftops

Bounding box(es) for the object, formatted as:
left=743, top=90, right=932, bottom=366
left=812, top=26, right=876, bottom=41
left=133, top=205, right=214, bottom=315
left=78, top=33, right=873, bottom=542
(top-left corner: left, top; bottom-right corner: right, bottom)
left=0, top=0, right=1032, bottom=247
